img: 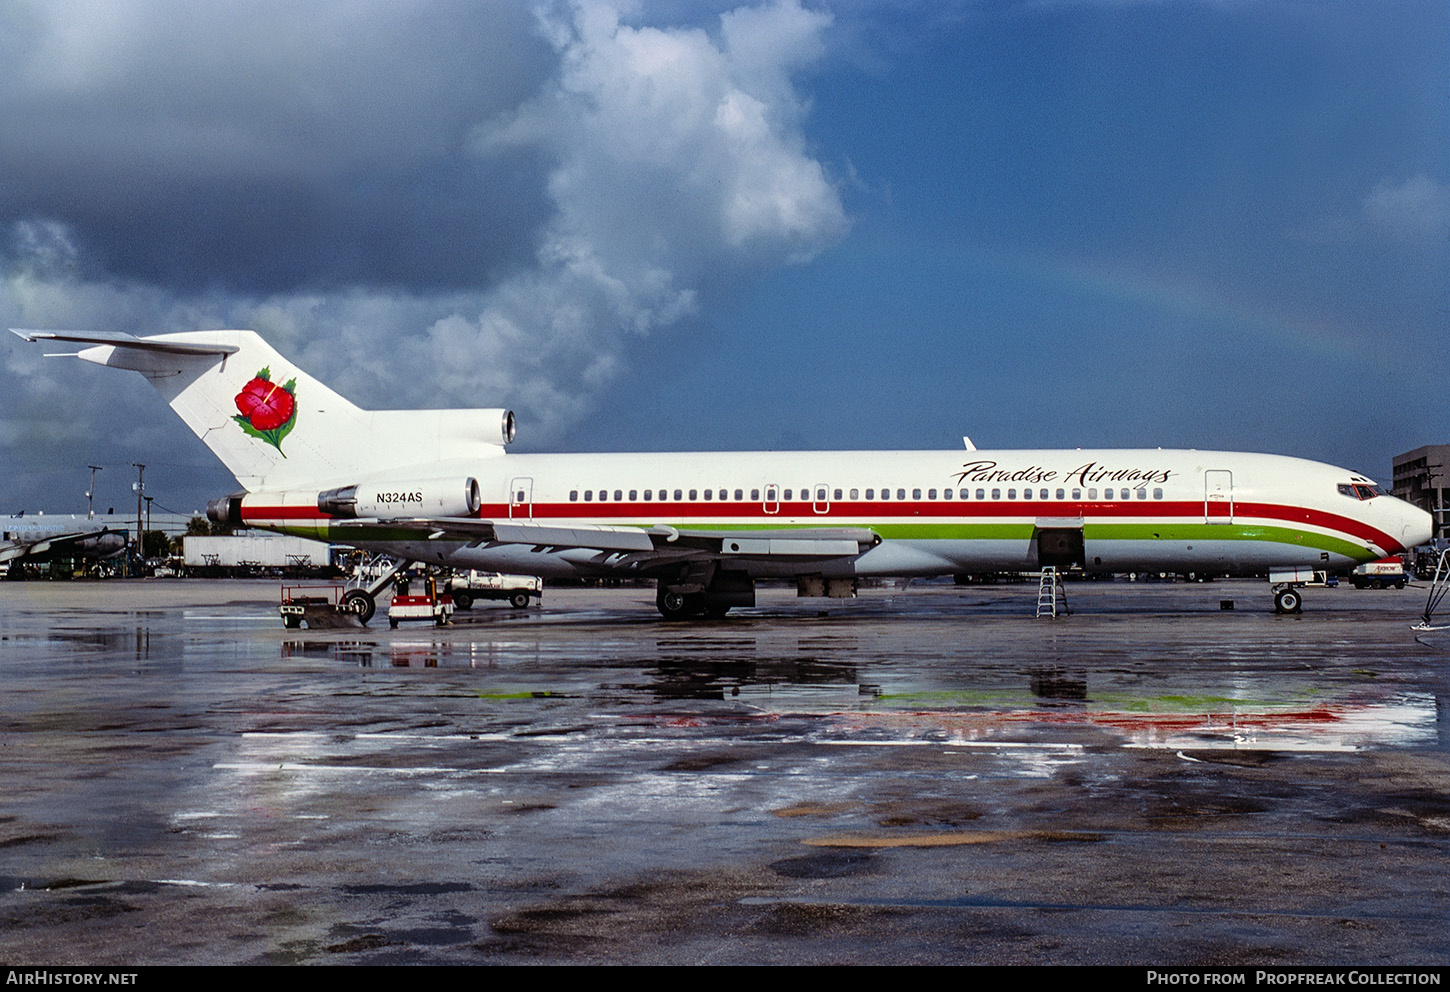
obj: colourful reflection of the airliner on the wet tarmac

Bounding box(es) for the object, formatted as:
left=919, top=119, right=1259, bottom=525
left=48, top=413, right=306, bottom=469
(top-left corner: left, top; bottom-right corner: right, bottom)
left=281, top=638, right=1438, bottom=753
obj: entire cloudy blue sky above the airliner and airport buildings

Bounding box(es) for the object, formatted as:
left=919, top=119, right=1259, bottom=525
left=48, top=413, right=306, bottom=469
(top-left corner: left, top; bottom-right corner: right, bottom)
left=0, top=0, right=1450, bottom=512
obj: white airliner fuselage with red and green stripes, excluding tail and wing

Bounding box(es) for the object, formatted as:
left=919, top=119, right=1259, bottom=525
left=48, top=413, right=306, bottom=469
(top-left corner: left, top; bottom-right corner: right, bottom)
left=244, top=450, right=1430, bottom=577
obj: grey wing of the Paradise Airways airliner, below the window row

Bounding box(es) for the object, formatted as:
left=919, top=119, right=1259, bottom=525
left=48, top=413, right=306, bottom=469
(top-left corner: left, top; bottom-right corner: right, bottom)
left=368, top=516, right=882, bottom=556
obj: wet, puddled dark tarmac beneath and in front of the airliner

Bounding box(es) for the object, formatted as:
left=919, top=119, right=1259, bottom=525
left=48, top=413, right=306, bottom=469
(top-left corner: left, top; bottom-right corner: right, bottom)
left=0, top=580, right=1450, bottom=966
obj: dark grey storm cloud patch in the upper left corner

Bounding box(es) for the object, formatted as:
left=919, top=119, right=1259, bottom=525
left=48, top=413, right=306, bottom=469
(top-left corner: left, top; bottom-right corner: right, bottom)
left=0, top=1, right=554, bottom=292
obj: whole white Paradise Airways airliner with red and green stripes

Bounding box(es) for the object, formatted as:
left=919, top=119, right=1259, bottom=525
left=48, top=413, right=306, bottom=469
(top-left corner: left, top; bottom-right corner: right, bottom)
left=16, top=331, right=1431, bottom=618
